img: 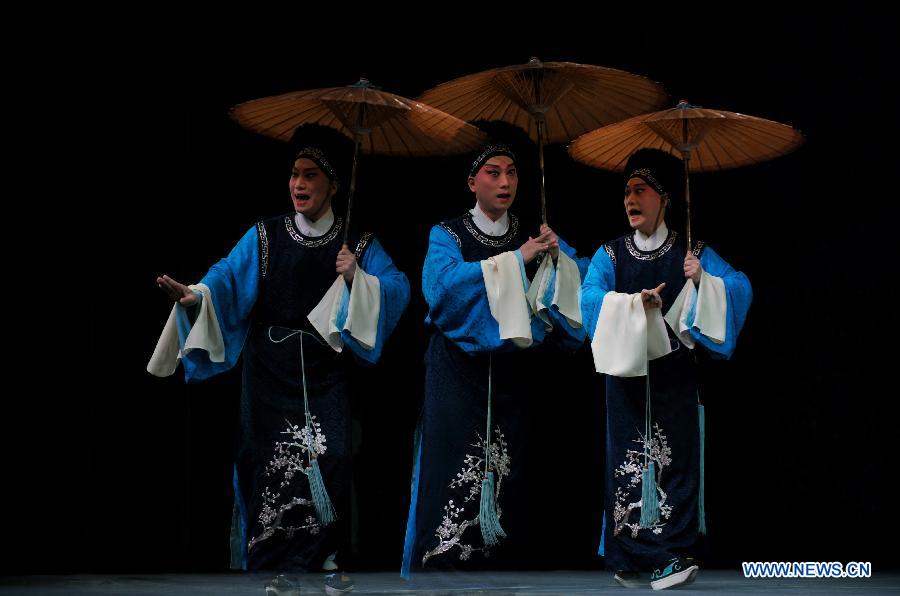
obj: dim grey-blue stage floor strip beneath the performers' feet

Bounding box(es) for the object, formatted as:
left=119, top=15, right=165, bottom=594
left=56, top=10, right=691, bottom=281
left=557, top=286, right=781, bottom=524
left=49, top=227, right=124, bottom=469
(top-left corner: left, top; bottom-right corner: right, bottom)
left=0, top=570, right=900, bottom=596
